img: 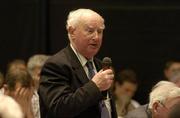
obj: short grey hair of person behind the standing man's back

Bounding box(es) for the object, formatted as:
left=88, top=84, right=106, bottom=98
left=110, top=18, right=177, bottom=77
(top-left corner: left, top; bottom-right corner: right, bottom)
left=27, top=54, right=50, bottom=76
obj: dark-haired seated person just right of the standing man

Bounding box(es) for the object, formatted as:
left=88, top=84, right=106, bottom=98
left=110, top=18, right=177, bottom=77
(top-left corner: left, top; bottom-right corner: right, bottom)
left=113, top=69, right=139, bottom=117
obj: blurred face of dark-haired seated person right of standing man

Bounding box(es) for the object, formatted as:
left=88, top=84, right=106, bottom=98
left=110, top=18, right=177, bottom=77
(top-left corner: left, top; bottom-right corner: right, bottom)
left=115, top=81, right=137, bottom=98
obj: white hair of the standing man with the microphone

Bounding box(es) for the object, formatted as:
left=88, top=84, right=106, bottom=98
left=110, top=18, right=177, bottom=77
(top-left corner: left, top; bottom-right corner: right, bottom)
left=66, top=8, right=105, bottom=41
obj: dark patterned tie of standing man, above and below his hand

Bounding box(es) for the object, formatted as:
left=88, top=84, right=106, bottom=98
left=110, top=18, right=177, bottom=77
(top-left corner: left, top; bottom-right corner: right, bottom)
left=86, top=61, right=111, bottom=118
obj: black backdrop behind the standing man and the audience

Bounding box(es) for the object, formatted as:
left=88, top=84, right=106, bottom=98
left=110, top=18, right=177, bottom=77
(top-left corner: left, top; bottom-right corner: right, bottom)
left=0, top=0, right=180, bottom=104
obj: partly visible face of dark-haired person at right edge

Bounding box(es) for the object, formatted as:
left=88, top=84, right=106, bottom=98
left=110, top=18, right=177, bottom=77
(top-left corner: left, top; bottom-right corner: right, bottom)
left=164, top=62, right=180, bottom=80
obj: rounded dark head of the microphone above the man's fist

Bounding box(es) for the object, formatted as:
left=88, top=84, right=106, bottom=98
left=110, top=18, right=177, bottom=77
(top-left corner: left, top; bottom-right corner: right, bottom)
left=102, top=57, right=112, bottom=70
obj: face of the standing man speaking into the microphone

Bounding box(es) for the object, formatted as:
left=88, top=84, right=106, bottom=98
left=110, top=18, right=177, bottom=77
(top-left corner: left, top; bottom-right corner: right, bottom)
left=71, top=14, right=104, bottom=59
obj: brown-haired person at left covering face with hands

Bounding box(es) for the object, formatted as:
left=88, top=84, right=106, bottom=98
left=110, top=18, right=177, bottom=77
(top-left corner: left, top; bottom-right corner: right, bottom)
left=2, top=68, right=34, bottom=118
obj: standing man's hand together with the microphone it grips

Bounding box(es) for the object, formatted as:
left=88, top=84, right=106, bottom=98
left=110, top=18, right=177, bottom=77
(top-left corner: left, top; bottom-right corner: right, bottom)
left=92, top=57, right=114, bottom=91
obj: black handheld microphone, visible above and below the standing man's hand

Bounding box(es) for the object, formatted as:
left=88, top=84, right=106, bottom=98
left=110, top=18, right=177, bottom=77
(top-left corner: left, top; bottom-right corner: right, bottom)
left=102, top=57, right=112, bottom=100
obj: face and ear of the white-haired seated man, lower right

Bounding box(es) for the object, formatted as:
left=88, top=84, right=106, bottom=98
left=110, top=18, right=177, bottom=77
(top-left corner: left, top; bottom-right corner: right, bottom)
left=153, top=97, right=180, bottom=118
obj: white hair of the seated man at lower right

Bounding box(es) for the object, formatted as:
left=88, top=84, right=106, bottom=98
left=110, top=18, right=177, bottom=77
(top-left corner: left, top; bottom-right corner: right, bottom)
left=149, top=81, right=180, bottom=109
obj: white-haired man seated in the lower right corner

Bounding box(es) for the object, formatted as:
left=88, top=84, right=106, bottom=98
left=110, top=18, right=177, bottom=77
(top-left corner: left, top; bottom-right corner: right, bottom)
left=125, top=81, right=180, bottom=118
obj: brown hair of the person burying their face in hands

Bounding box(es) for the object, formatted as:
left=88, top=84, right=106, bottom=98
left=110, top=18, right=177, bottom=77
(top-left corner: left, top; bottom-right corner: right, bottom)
left=5, top=69, right=33, bottom=90
